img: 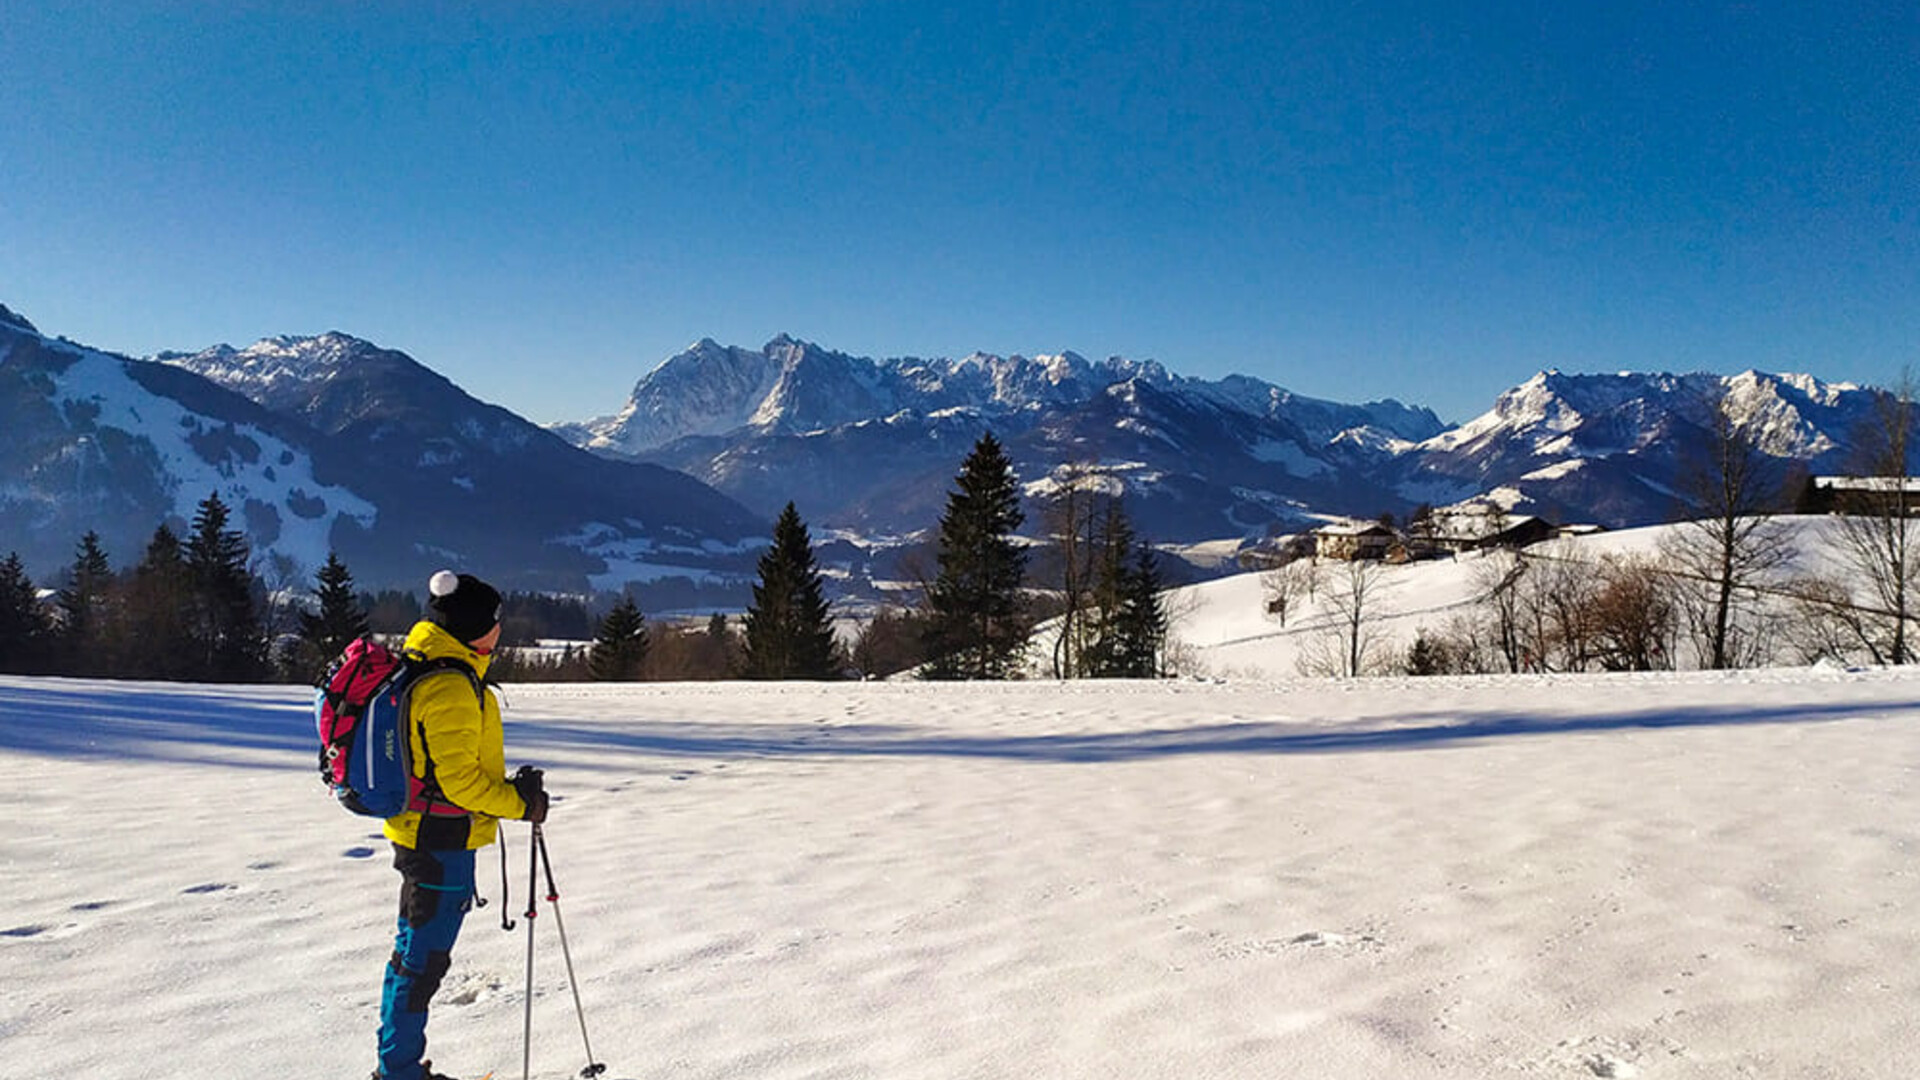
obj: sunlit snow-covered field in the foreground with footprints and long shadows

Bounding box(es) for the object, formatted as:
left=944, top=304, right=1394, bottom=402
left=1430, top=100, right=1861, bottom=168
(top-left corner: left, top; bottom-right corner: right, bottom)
left=0, top=653, right=1920, bottom=1080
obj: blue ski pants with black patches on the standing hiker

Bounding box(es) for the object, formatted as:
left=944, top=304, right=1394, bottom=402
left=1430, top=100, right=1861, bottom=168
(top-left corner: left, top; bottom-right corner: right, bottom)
left=378, top=844, right=474, bottom=1080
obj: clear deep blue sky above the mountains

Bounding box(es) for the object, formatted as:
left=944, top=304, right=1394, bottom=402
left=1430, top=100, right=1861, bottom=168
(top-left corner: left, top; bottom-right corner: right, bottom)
left=0, top=0, right=1920, bottom=421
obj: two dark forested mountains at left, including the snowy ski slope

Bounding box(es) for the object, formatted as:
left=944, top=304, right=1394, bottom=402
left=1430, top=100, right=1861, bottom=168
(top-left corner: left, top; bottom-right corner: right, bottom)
left=0, top=309, right=764, bottom=603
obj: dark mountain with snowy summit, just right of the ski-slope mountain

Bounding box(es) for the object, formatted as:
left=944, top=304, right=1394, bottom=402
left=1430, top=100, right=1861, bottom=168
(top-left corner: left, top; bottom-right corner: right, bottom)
left=145, top=334, right=764, bottom=595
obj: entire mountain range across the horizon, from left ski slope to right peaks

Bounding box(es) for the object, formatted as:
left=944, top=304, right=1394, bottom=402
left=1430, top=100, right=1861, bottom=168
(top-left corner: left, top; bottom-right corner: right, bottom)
left=0, top=297, right=1876, bottom=609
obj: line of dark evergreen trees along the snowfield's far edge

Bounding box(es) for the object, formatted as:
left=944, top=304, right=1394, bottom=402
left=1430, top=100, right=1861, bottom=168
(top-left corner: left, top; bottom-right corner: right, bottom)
left=0, top=434, right=1167, bottom=682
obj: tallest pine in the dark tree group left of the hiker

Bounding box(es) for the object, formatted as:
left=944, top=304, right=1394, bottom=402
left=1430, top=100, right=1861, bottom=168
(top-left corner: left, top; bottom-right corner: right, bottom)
left=186, top=492, right=267, bottom=682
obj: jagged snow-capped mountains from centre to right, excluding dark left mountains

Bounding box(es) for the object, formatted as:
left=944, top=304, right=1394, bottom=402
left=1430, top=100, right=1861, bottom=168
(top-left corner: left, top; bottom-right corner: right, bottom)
left=557, top=336, right=1874, bottom=544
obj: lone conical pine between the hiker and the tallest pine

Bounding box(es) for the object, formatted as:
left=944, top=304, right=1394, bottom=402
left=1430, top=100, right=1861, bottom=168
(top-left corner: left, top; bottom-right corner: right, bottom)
left=741, top=502, right=839, bottom=678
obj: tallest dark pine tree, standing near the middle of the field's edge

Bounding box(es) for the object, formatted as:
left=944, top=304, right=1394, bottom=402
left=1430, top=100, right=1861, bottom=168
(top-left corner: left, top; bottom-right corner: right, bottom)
left=924, top=432, right=1029, bottom=678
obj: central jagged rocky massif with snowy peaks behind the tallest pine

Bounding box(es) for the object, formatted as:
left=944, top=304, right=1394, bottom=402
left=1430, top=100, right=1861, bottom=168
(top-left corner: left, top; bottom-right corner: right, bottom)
left=555, top=336, right=1440, bottom=540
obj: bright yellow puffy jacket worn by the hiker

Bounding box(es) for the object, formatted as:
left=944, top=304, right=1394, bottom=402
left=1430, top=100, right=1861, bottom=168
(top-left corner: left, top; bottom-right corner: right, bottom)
left=384, top=621, right=526, bottom=849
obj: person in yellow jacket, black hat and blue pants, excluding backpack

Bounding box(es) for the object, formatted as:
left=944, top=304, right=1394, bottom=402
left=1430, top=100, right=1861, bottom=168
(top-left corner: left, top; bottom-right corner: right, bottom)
left=374, top=571, right=547, bottom=1080
